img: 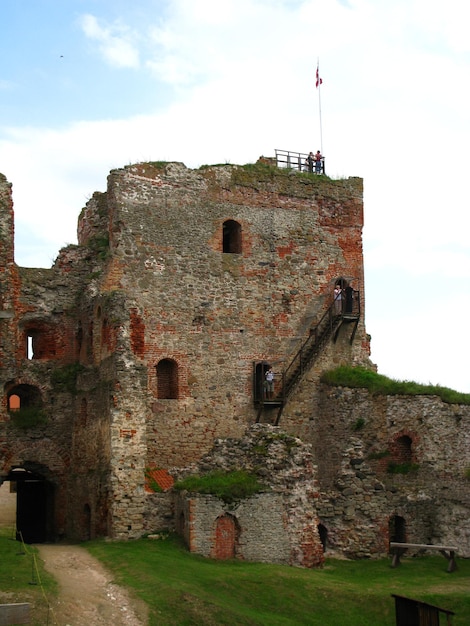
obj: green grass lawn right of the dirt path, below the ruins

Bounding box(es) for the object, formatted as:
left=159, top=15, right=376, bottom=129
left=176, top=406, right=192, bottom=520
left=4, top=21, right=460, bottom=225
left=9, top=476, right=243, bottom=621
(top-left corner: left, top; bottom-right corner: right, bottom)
left=84, top=537, right=470, bottom=626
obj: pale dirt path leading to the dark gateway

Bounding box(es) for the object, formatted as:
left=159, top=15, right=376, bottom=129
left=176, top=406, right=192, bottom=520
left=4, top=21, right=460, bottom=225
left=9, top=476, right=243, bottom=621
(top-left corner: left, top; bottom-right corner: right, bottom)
left=36, top=544, right=147, bottom=626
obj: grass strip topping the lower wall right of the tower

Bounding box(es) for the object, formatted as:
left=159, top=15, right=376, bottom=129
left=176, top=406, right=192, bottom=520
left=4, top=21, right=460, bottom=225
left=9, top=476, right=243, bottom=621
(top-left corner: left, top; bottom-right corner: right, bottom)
left=321, top=365, right=470, bottom=404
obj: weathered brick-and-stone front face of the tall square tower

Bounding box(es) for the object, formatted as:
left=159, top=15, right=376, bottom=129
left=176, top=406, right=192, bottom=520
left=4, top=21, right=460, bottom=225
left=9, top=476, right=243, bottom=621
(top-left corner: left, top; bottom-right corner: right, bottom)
left=94, top=163, right=369, bottom=467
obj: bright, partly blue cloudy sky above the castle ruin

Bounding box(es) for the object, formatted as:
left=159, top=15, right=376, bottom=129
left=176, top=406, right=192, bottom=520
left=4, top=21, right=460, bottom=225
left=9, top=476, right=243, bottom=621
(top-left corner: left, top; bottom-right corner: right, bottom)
left=0, top=0, right=470, bottom=393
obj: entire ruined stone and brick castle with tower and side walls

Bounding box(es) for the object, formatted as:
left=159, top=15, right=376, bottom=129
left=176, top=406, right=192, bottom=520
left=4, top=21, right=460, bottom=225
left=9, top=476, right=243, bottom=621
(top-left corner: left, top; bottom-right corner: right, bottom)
left=0, top=159, right=470, bottom=567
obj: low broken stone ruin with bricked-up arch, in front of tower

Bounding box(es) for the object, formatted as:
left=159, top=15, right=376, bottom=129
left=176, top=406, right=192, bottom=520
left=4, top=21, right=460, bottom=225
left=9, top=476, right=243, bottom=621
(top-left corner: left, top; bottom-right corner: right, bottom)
left=172, top=424, right=324, bottom=567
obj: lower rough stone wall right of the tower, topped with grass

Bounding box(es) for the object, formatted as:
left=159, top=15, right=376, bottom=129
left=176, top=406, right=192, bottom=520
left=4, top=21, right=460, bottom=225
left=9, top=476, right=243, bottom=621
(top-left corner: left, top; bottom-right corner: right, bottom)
left=312, top=386, right=470, bottom=557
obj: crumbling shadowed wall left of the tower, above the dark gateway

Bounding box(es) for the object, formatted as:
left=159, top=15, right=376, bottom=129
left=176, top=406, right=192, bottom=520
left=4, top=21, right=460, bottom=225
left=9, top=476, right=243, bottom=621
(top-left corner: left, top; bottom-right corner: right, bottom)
left=0, top=172, right=116, bottom=540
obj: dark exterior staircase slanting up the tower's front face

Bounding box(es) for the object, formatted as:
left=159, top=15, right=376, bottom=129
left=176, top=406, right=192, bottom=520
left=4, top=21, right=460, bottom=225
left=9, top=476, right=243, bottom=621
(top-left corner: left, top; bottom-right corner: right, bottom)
left=255, top=291, right=360, bottom=425
